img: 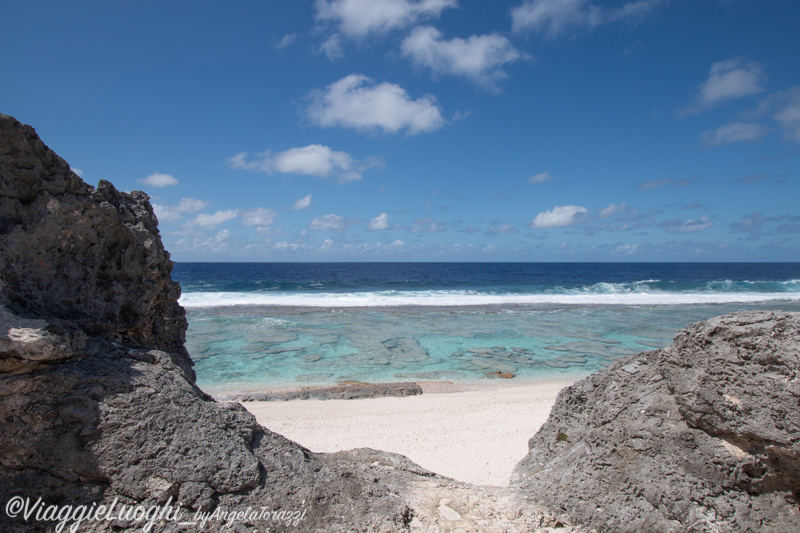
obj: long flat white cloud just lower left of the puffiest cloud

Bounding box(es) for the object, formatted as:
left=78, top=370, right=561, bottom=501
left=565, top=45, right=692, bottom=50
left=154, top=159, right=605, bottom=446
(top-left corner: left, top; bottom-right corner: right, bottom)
left=228, top=144, right=381, bottom=183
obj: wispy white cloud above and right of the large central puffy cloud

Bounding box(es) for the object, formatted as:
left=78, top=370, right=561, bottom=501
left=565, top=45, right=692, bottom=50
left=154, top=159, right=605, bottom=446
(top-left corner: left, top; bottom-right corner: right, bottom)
left=402, top=26, right=523, bottom=88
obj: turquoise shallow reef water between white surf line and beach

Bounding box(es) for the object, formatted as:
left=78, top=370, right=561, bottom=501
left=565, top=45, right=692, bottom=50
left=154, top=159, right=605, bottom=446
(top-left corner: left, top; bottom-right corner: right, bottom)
left=187, top=302, right=800, bottom=394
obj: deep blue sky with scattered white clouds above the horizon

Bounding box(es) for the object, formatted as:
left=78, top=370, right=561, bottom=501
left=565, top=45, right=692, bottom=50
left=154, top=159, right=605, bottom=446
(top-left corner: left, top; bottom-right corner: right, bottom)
left=0, top=0, right=800, bottom=261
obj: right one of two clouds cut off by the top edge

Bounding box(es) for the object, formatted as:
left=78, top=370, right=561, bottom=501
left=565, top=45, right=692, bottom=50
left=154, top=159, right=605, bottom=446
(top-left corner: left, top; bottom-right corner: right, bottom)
left=511, top=0, right=667, bottom=38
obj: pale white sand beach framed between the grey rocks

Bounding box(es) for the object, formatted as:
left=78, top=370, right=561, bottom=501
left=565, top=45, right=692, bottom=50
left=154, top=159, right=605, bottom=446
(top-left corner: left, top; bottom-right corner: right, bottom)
left=242, top=380, right=574, bottom=485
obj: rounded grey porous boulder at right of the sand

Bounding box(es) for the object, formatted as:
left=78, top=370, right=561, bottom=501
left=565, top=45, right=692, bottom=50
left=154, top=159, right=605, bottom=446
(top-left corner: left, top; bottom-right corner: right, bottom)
left=512, top=312, right=800, bottom=533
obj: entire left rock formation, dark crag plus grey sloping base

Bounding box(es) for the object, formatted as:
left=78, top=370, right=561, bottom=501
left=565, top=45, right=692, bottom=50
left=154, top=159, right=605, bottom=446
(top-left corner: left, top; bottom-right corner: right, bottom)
left=0, top=115, right=583, bottom=532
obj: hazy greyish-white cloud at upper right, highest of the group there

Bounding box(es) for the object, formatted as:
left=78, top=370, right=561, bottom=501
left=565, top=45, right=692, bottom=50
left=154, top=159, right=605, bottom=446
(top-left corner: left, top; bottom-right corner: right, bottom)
left=698, top=58, right=764, bottom=106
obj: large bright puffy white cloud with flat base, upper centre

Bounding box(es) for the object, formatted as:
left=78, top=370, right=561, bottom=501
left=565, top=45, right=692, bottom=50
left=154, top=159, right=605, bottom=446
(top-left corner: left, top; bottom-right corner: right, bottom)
left=308, top=74, right=445, bottom=135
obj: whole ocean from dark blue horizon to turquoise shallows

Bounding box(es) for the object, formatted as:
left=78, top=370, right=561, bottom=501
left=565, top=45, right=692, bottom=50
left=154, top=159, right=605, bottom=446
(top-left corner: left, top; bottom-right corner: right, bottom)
left=172, top=263, right=800, bottom=394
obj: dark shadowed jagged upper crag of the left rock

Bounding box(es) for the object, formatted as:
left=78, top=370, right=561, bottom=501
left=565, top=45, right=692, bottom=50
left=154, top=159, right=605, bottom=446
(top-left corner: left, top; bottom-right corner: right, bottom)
left=0, top=115, right=191, bottom=373
